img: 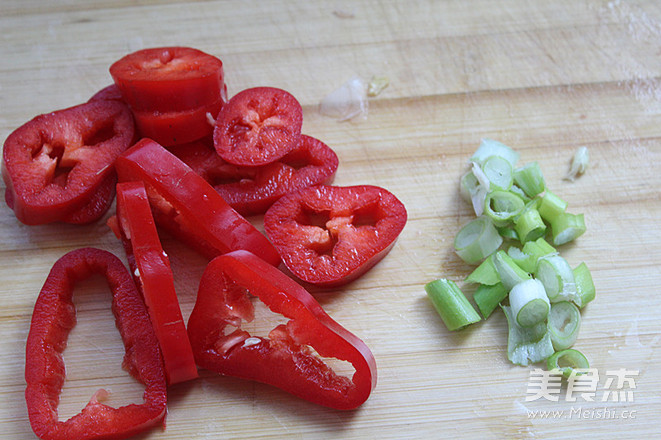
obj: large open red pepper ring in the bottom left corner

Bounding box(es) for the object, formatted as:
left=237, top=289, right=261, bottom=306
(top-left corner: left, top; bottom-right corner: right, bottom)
left=25, top=248, right=167, bottom=440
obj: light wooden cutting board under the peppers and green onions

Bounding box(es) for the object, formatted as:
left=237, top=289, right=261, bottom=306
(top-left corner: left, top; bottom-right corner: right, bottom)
left=0, top=0, right=661, bottom=439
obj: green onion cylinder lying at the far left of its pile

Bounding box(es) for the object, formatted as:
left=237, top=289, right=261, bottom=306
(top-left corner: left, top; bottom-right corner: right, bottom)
left=425, top=278, right=481, bottom=331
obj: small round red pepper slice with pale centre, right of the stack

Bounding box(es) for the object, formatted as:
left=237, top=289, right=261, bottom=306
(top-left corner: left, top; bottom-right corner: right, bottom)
left=213, top=87, right=303, bottom=166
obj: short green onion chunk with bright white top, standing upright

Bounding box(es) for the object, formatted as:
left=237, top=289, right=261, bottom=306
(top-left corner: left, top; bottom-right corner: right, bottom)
left=510, top=279, right=553, bottom=326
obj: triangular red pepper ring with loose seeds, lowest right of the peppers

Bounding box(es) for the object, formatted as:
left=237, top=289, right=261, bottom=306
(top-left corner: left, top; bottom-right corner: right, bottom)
left=188, top=251, right=376, bottom=409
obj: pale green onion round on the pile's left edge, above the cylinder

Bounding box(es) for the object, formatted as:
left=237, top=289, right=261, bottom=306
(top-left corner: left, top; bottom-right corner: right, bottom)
left=454, top=216, right=503, bottom=264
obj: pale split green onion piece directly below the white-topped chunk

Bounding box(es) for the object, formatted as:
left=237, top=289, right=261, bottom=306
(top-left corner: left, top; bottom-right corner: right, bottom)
left=501, top=306, right=553, bottom=366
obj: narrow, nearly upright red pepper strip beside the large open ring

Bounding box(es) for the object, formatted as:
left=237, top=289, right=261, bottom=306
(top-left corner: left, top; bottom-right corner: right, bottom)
left=115, top=182, right=197, bottom=385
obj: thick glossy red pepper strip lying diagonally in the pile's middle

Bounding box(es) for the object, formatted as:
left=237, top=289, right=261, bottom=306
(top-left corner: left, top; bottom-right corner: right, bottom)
left=115, top=139, right=280, bottom=265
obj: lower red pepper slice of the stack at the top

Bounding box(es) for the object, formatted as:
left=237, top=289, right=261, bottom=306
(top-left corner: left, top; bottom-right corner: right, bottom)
left=133, top=99, right=224, bottom=147
